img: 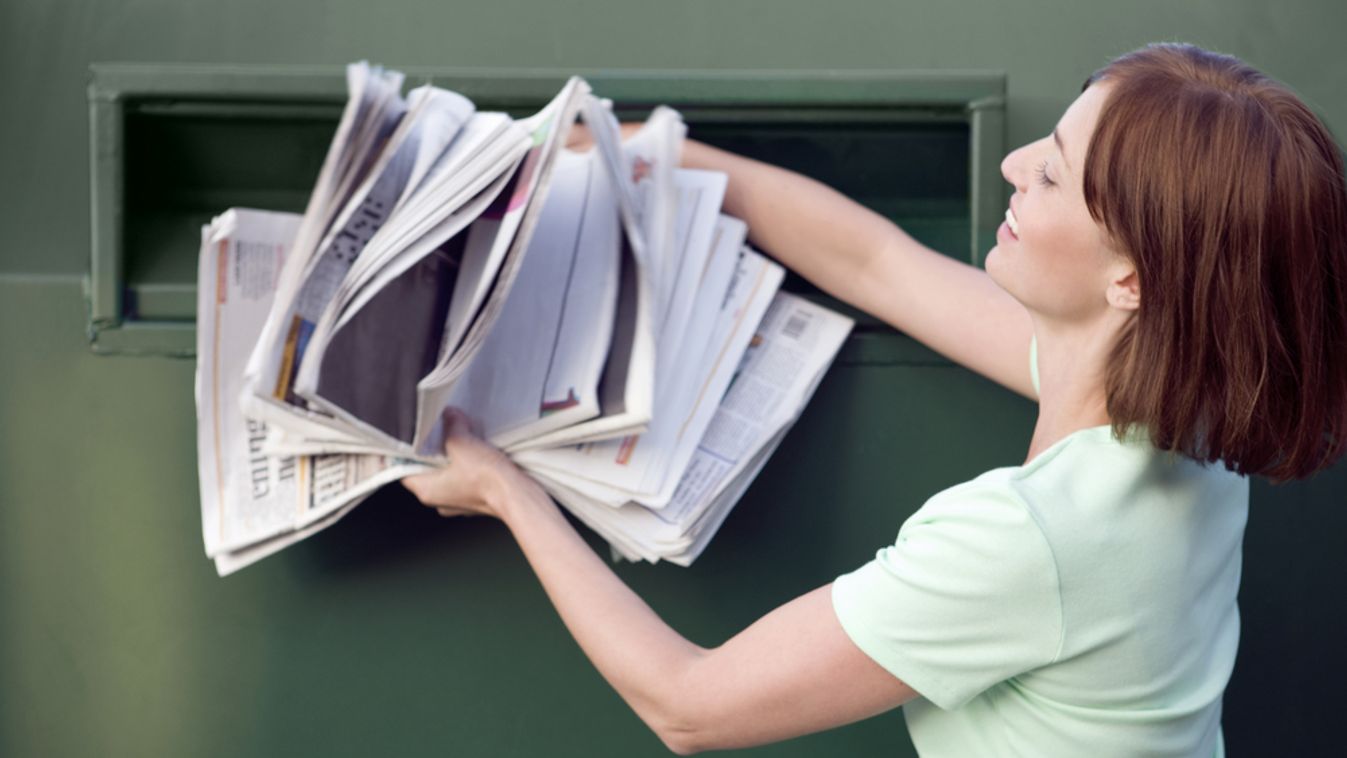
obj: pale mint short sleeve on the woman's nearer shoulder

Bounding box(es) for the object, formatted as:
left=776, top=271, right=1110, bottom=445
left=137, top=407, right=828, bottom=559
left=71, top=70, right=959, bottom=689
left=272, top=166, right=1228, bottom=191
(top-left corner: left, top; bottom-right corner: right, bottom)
left=832, top=481, right=1063, bottom=710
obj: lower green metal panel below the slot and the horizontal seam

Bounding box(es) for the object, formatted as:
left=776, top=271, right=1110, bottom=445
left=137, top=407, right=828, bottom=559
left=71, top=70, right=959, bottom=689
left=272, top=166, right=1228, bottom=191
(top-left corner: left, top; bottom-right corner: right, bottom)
left=0, top=277, right=1033, bottom=757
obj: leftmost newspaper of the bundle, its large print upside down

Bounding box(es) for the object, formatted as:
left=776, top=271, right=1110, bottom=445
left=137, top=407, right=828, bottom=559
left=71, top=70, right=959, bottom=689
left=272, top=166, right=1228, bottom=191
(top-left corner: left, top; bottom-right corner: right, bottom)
left=197, top=209, right=426, bottom=568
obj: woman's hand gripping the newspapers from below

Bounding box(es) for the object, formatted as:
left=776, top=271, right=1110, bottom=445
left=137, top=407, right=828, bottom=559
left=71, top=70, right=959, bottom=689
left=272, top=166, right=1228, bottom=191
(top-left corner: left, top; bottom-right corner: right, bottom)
left=403, top=408, right=523, bottom=518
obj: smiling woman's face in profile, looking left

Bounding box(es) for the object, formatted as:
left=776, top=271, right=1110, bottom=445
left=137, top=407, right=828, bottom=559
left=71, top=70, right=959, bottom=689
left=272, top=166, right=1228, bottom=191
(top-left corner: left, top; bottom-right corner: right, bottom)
left=986, top=83, right=1133, bottom=322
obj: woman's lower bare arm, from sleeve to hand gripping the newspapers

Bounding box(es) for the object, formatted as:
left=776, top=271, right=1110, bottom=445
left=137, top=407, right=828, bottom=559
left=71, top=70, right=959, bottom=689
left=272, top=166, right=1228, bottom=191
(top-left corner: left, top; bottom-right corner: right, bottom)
left=404, top=416, right=916, bottom=754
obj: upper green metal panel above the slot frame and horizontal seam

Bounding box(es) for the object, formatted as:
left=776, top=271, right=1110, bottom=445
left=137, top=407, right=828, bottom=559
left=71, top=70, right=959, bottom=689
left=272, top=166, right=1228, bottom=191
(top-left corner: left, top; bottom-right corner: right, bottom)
left=0, top=0, right=1347, bottom=273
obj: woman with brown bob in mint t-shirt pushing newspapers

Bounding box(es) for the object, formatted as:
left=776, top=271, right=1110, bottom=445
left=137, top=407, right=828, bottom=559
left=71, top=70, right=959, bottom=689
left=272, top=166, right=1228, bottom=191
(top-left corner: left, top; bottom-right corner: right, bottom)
left=407, top=44, right=1347, bottom=757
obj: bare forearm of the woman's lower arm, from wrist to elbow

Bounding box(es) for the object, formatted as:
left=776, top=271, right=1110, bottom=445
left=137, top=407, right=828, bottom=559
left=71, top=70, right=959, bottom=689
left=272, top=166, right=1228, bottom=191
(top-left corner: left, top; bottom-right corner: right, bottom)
left=494, top=473, right=706, bottom=743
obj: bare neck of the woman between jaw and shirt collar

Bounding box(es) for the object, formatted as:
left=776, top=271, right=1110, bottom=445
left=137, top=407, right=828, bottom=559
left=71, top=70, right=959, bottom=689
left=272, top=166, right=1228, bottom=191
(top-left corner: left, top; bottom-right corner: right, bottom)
left=1025, top=319, right=1123, bottom=463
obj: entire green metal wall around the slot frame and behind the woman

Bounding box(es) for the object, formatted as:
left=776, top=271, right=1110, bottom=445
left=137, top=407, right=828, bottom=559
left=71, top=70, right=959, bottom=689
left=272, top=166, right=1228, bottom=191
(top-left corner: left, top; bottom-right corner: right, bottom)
left=0, top=0, right=1347, bottom=755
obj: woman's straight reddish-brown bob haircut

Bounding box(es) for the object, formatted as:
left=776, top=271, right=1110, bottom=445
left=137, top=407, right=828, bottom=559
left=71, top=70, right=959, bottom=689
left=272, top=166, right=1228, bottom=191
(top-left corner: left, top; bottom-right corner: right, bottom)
left=1082, top=43, right=1347, bottom=481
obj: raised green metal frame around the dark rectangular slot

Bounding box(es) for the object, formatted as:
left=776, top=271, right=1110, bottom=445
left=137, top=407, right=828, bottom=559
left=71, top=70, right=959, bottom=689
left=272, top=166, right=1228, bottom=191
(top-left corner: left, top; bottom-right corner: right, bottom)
left=88, top=65, right=1005, bottom=355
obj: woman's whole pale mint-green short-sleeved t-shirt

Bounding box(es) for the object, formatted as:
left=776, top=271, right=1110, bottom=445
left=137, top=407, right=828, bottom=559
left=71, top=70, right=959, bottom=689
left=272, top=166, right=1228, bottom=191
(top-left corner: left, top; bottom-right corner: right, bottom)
left=832, top=341, right=1249, bottom=758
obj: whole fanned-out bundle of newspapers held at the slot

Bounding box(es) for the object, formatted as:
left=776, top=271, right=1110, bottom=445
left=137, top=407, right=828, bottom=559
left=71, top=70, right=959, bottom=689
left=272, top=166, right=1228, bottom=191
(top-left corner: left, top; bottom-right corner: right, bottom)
left=197, top=63, right=851, bottom=575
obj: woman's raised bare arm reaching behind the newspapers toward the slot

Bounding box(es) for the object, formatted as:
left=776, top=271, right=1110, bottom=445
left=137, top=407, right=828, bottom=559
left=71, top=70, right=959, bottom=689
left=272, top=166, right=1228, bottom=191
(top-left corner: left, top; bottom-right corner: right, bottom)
left=683, top=140, right=1036, bottom=399
